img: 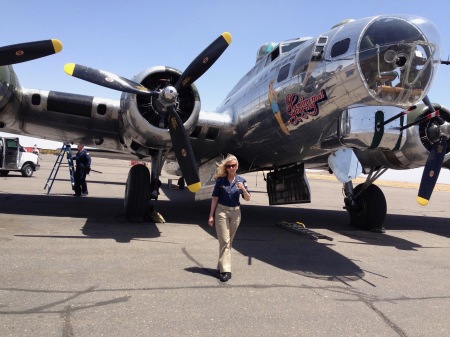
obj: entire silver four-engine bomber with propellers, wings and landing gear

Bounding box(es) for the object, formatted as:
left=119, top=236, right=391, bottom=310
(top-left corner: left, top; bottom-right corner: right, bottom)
left=0, top=15, right=450, bottom=231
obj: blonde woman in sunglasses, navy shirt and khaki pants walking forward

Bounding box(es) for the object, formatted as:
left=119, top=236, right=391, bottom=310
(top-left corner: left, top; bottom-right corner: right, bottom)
left=208, top=155, right=250, bottom=282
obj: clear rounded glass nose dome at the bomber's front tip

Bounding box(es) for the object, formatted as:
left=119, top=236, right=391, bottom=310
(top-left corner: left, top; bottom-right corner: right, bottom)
left=359, top=18, right=436, bottom=105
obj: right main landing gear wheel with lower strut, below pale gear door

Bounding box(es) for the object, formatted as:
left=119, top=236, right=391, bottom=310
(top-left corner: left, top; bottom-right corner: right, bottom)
left=344, top=182, right=387, bottom=233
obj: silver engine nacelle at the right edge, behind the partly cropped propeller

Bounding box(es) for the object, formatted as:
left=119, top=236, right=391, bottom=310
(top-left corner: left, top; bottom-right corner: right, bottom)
left=388, top=104, right=450, bottom=168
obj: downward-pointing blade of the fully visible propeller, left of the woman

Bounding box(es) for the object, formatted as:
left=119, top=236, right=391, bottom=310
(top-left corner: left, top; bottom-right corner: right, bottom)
left=169, top=106, right=202, bottom=193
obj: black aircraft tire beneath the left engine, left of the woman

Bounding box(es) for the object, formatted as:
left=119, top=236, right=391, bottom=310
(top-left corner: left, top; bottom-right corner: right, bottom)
left=124, top=165, right=150, bottom=222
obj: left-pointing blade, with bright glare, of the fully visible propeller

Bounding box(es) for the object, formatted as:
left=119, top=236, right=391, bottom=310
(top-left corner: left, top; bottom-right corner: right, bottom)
left=64, top=63, right=158, bottom=95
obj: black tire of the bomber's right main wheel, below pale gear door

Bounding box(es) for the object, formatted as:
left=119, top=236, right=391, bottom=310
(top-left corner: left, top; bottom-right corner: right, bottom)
left=347, top=184, right=387, bottom=230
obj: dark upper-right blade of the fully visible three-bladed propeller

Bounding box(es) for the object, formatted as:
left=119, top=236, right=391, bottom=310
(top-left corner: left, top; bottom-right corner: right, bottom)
left=175, top=32, right=231, bottom=91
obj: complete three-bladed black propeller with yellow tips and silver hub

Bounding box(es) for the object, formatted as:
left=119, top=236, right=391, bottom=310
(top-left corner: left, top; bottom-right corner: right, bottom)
left=64, top=32, right=231, bottom=192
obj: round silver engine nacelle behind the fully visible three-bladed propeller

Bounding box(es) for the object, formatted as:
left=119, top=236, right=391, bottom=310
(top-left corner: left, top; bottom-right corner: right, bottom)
left=119, top=66, right=200, bottom=156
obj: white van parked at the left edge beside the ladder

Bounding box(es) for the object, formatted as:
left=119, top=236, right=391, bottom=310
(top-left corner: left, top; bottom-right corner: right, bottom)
left=0, top=137, right=40, bottom=177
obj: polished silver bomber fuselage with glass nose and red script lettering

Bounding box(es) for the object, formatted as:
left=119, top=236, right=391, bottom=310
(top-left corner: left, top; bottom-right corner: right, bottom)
left=199, top=16, right=440, bottom=167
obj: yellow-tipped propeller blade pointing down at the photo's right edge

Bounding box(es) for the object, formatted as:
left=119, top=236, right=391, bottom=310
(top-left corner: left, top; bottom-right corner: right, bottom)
left=417, top=136, right=447, bottom=206
